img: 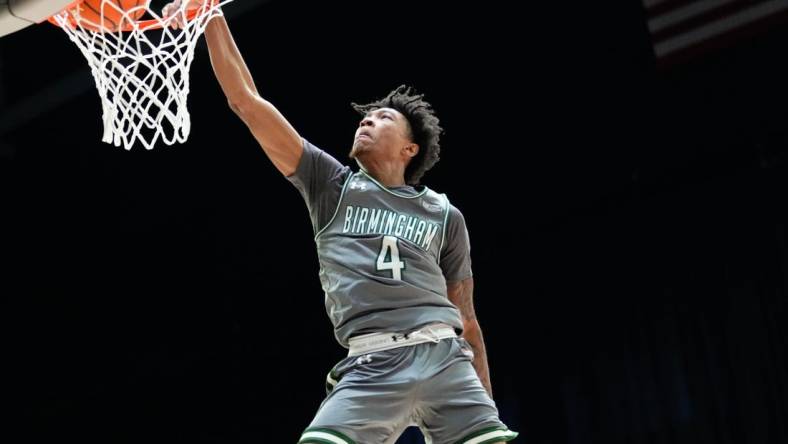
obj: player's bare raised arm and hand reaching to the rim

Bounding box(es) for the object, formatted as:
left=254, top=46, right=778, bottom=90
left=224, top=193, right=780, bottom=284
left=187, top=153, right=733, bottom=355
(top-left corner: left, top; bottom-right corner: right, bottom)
left=162, top=0, right=303, bottom=176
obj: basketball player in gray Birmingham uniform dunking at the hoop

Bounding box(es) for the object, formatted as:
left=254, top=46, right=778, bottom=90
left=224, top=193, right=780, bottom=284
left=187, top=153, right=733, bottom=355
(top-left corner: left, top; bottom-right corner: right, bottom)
left=162, top=0, right=517, bottom=444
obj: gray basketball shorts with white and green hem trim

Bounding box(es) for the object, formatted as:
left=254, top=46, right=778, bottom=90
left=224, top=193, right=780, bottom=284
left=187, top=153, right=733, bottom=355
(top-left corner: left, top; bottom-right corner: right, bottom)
left=298, top=338, right=517, bottom=444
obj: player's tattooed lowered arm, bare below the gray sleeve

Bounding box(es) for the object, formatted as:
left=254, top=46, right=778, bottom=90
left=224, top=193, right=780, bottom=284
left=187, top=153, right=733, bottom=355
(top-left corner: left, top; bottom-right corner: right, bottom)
left=447, top=277, right=492, bottom=398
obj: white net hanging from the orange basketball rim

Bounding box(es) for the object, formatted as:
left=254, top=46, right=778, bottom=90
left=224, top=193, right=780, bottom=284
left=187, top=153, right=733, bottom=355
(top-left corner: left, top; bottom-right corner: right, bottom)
left=53, top=0, right=231, bottom=150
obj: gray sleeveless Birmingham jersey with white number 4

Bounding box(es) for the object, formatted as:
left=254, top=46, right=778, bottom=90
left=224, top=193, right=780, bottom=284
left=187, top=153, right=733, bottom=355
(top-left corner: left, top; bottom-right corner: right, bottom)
left=315, top=171, right=462, bottom=347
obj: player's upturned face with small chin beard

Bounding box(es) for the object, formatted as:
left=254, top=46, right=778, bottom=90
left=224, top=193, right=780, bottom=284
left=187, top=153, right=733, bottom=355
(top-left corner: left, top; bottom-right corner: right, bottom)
left=350, top=108, right=412, bottom=160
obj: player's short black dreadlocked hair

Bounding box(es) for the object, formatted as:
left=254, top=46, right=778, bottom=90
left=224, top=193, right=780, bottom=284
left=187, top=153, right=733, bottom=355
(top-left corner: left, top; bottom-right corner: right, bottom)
left=351, top=85, right=443, bottom=186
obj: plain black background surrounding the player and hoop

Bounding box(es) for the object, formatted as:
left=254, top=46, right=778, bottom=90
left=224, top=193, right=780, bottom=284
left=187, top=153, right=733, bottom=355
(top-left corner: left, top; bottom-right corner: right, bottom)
left=0, top=0, right=788, bottom=444
